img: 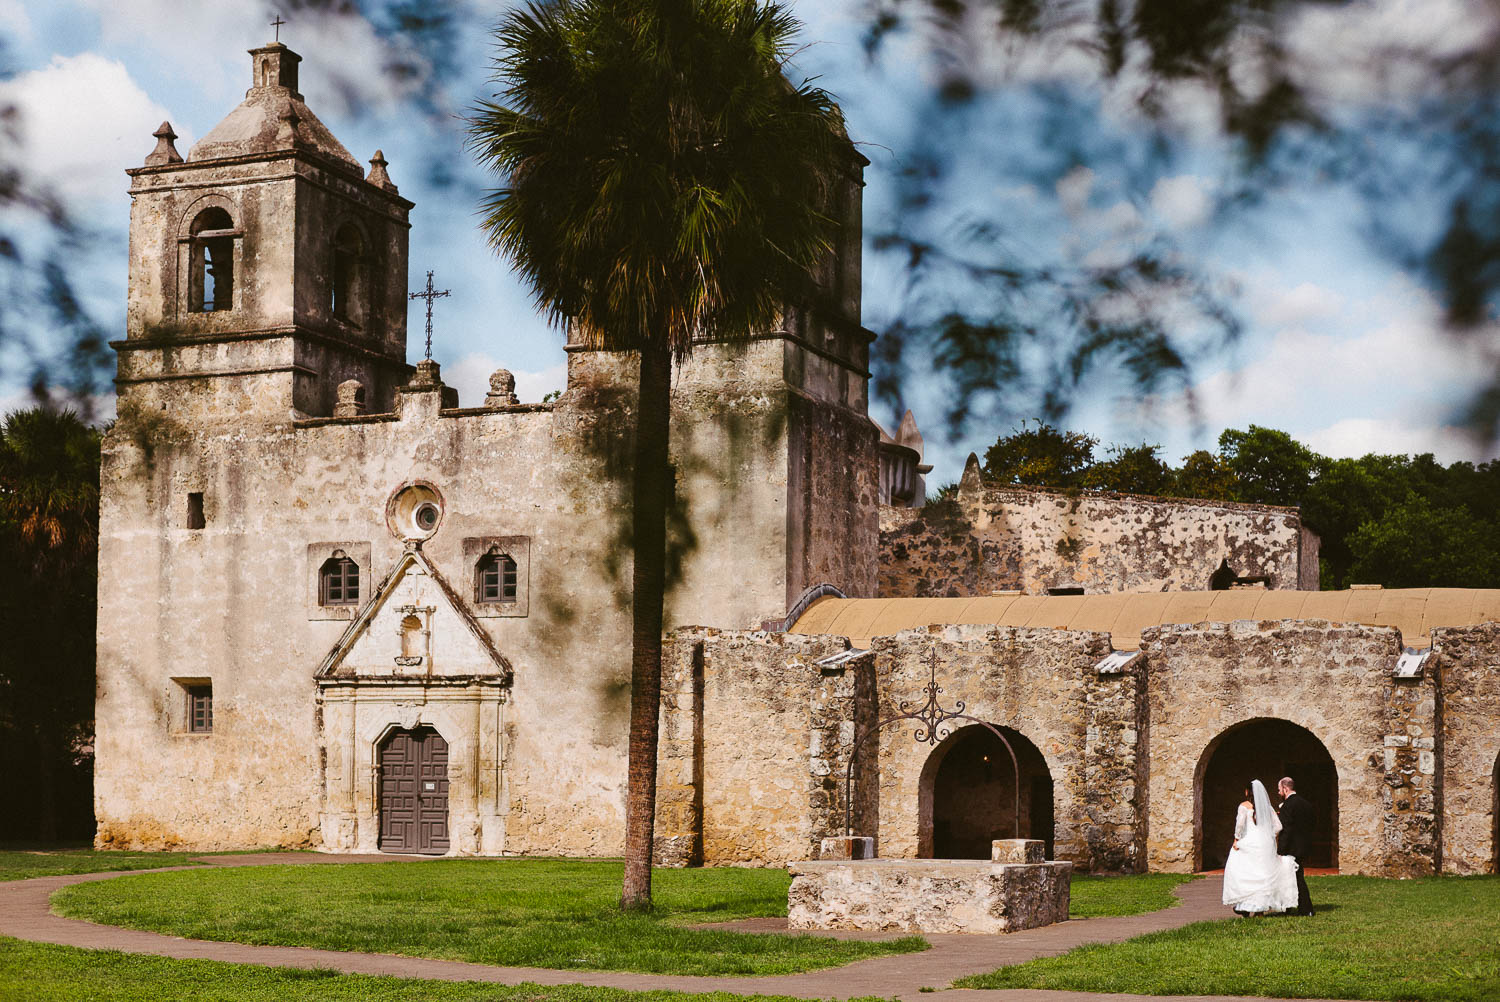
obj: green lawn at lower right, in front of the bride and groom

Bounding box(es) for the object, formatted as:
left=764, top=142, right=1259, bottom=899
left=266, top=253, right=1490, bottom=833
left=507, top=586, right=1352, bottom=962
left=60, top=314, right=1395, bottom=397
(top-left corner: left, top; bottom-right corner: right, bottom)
left=957, top=876, right=1500, bottom=1002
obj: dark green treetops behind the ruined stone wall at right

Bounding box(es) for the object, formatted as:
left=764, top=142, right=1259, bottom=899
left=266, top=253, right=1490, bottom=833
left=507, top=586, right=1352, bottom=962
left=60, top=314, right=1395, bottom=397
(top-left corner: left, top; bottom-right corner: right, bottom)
left=978, top=422, right=1500, bottom=588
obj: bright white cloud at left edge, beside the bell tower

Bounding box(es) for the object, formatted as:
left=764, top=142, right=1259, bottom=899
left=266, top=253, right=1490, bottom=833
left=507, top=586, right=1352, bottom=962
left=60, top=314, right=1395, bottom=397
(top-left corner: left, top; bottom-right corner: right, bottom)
left=0, top=53, right=188, bottom=206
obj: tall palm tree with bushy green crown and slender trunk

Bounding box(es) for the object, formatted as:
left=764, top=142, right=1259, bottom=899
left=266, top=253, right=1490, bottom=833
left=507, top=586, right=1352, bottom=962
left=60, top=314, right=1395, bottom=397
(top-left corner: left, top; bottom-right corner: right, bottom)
left=470, top=0, right=852, bottom=908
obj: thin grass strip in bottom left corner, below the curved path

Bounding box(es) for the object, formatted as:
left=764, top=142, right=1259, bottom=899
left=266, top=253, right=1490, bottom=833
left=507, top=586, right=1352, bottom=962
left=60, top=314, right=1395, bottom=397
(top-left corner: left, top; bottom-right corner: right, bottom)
left=0, top=939, right=888, bottom=1002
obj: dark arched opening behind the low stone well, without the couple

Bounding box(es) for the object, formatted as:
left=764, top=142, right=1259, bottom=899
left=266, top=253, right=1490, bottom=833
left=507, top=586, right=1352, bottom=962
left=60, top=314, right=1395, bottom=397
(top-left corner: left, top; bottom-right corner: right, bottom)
left=917, top=725, right=1055, bottom=860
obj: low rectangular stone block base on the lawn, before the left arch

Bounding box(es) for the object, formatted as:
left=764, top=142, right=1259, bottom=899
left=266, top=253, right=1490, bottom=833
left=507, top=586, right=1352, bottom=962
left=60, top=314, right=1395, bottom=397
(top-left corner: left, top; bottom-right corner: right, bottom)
left=786, top=860, right=1073, bottom=933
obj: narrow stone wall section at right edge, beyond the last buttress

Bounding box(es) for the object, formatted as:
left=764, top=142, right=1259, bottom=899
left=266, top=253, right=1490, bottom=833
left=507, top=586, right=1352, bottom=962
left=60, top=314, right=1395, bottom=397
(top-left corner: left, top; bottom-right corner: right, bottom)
left=1419, top=623, right=1500, bottom=873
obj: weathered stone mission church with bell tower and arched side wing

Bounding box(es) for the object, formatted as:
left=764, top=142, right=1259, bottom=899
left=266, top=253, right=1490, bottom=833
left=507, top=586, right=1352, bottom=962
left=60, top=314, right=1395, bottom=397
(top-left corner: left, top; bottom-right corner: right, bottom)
left=95, top=45, right=1500, bottom=873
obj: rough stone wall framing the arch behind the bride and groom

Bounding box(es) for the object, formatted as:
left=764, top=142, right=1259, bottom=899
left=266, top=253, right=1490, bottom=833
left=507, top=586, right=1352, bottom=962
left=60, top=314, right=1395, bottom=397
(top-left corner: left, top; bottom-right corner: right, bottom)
left=1142, top=620, right=1436, bottom=876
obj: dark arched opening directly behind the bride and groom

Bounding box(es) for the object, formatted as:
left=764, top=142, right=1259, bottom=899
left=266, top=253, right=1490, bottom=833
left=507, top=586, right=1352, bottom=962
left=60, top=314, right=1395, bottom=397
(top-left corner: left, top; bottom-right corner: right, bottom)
left=1193, top=717, right=1338, bottom=870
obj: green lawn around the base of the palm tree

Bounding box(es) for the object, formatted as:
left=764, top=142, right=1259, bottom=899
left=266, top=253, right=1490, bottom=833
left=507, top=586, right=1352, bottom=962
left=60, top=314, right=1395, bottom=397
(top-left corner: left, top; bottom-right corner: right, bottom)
left=53, top=860, right=927, bottom=975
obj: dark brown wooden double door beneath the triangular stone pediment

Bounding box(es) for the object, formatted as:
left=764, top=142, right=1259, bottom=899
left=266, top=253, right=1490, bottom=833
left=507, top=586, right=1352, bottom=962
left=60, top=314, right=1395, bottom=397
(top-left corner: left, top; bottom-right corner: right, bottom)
left=380, top=728, right=449, bottom=855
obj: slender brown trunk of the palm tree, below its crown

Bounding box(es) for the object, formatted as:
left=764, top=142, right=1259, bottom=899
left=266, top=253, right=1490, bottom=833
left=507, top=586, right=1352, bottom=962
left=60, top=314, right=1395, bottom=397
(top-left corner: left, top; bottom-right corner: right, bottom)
left=620, top=342, right=672, bottom=909
